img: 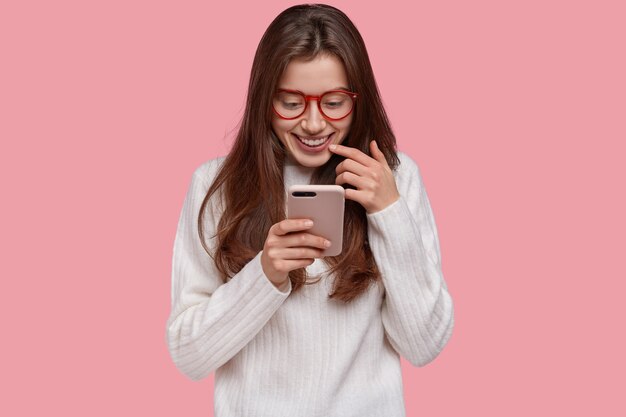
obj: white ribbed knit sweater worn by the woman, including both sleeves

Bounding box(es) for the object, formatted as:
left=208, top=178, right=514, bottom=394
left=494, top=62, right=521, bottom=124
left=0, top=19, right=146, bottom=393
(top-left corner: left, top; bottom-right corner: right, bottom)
left=166, top=152, right=454, bottom=417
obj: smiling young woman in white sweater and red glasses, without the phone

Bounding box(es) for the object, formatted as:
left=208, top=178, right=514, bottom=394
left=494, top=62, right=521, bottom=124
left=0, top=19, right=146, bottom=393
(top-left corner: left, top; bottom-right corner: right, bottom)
left=167, top=5, right=454, bottom=417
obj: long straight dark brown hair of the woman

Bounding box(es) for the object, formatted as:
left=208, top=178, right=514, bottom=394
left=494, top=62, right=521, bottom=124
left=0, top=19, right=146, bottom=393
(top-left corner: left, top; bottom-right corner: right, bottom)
left=198, top=4, right=400, bottom=303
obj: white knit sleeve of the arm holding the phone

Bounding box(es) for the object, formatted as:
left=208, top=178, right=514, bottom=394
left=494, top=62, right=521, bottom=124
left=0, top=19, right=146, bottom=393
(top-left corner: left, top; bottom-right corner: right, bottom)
left=166, top=160, right=291, bottom=381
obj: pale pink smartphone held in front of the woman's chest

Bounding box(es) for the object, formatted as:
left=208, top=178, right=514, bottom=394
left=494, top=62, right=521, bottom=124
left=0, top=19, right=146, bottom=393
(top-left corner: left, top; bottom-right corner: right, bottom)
left=287, top=184, right=346, bottom=256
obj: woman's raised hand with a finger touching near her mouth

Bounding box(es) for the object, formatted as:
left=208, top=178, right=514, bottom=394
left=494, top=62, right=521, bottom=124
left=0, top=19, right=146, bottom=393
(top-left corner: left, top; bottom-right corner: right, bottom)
left=329, top=141, right=400, bottom=214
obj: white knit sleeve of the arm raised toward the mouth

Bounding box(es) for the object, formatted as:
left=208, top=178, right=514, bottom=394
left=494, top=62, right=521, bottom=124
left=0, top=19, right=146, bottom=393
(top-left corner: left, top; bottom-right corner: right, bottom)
left=367, top=154, right=454, bottom=366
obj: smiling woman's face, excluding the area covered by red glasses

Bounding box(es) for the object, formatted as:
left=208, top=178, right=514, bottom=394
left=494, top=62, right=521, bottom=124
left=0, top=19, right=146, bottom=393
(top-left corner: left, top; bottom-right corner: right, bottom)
left=272, top=55, right=353, bottom=167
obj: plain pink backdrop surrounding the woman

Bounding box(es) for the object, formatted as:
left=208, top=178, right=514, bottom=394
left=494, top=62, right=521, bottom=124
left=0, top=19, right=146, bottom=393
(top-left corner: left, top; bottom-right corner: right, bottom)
left=0, top=0, right=626, bottom=416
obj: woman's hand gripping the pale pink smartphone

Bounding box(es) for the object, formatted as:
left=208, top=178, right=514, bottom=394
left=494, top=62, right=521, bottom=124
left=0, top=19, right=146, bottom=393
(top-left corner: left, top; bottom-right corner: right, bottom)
left=261, top=219, right=330, bottom=287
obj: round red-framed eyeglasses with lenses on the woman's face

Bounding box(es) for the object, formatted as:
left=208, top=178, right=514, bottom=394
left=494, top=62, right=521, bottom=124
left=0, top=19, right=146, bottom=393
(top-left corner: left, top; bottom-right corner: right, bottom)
left=272, top=88, right=359, bottom=120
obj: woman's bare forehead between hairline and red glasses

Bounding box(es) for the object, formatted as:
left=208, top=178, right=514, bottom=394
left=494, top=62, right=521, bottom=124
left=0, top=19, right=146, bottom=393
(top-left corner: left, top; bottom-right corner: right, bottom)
left=278, top=55, right=348, bottom=94
